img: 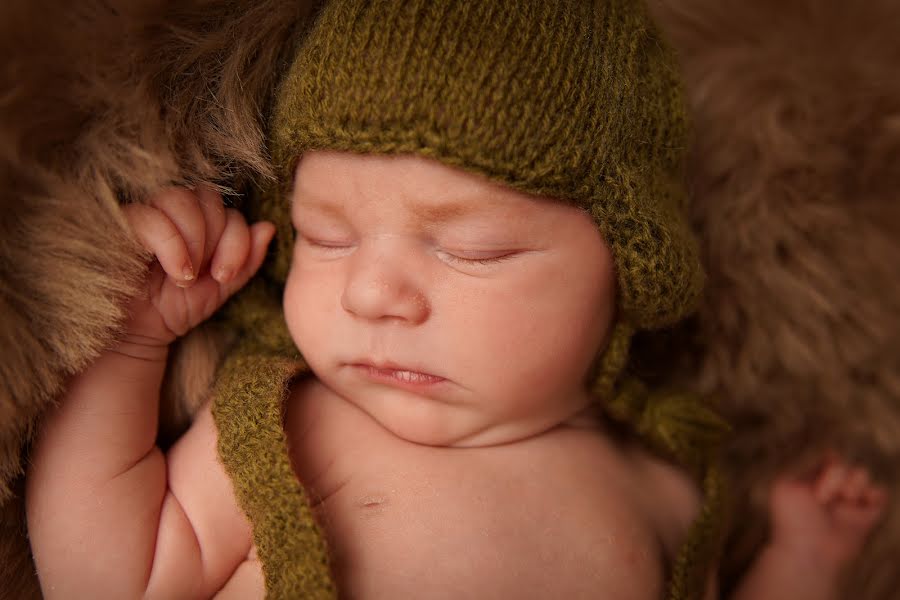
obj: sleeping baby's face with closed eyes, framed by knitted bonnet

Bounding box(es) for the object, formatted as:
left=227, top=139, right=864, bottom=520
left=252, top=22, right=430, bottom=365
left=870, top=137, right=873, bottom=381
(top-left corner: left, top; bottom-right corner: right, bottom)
left=284, top=152, right=614, bottom=446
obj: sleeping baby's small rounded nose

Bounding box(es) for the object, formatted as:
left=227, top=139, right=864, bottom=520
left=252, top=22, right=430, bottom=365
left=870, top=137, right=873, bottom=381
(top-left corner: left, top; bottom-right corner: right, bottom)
left=341, top=248, right=431, bottom=325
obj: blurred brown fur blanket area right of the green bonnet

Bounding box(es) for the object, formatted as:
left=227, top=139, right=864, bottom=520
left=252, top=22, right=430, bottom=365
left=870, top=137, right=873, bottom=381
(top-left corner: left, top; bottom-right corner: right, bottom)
left=656, top=0, right=900, bottom=600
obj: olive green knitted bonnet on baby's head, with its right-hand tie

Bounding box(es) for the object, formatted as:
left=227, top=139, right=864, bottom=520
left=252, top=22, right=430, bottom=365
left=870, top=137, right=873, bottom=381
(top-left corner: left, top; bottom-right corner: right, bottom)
left=217, top=0, right=721, bottom=597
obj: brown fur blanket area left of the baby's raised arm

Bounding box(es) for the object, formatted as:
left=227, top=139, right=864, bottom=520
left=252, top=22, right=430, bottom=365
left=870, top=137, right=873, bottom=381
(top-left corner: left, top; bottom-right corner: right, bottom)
left=0, top=0, right=310, bottom=600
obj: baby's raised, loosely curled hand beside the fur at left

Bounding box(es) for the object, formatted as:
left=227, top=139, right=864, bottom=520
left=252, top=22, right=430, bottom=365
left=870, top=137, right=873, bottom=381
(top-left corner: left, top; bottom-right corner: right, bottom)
left=123, top=188, right=275, bottom=346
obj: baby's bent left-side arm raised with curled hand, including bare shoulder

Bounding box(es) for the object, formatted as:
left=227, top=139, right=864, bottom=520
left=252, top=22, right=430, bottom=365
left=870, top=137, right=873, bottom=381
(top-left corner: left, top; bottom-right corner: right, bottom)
left=26, top=189, right=274, bottom=598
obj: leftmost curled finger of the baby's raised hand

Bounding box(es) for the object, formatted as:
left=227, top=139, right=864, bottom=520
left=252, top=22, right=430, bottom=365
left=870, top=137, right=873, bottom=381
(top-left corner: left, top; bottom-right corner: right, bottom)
left=123, top=203, right=194, bottom=286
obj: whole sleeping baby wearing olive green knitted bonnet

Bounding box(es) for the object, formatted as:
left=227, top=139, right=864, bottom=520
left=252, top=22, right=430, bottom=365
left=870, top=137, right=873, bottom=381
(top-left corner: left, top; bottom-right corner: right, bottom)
left=27, top=0, right=884, bottom=599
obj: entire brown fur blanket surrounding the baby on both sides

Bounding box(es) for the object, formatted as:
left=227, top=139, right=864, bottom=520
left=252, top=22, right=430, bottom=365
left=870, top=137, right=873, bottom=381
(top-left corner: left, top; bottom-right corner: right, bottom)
left=0, top=0, right=900, bottom=600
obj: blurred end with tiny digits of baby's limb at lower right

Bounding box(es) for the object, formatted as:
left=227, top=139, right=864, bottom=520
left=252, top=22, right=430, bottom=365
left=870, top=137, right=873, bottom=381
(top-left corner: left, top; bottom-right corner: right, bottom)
left=770, top=456, right=887, bottom=575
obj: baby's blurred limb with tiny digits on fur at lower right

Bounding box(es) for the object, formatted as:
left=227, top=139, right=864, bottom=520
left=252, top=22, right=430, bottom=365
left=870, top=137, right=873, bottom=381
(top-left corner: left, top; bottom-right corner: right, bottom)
left=733, top=458, right=886, bottom=600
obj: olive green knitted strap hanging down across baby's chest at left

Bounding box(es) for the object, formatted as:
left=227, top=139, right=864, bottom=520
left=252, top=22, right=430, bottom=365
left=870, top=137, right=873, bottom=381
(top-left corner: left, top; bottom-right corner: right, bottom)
left=212, top=282, right=337, bottom=600
